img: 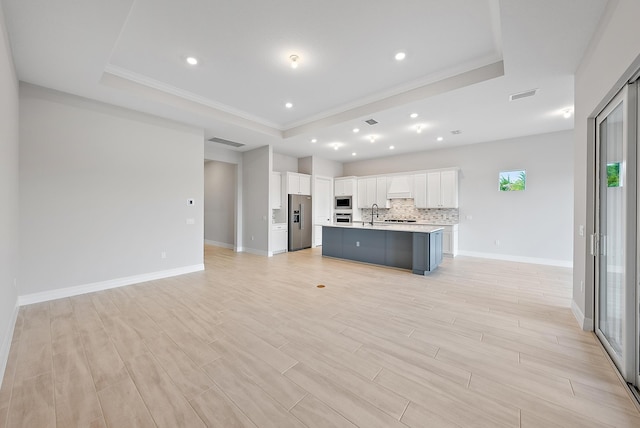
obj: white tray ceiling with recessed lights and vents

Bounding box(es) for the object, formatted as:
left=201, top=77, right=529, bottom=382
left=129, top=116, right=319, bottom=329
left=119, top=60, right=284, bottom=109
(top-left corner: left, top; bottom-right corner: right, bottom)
left=1, top=0, right=607, bottom=162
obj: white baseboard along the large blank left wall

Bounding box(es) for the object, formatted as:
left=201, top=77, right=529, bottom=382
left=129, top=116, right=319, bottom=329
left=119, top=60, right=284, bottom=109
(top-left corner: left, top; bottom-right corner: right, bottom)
left=18, top=263, right=204, bottom=306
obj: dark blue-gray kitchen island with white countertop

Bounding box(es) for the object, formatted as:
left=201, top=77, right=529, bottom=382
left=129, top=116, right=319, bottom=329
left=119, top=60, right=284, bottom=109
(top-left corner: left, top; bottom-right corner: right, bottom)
left=322, top=225, right=443, bottom=275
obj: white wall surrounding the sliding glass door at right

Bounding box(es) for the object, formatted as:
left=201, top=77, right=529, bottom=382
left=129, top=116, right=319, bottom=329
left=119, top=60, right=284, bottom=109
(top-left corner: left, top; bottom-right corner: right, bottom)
left=573, top=0, right=640, bottom=330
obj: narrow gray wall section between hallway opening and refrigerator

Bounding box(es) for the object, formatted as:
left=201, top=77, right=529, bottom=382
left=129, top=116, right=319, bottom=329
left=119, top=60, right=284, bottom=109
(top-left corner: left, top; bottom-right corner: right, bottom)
left=242, top=146, right=273, bottom=256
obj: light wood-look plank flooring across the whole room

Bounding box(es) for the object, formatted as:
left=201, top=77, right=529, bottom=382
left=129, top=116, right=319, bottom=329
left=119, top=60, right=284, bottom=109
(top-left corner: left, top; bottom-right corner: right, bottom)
left=0, top=247, right=640, bottom=428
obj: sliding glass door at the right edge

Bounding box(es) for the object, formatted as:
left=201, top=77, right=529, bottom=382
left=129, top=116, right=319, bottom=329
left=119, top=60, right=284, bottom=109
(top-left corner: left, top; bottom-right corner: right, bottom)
left=591, top=80, right=640, bottom=385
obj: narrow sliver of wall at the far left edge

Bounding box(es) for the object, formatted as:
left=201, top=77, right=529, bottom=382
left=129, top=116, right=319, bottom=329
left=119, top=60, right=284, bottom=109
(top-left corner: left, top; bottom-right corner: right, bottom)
left=0, top=4, right=19, bottom=386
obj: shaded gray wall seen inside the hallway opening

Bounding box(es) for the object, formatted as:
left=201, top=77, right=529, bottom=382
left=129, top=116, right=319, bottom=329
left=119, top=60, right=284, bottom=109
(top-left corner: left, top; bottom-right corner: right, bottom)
left=204, top=161, right=238, bottom=248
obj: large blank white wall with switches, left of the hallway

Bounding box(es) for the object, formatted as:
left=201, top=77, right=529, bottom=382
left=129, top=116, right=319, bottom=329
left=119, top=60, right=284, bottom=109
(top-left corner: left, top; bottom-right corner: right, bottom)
left=20, top=84, right=204, bottom=303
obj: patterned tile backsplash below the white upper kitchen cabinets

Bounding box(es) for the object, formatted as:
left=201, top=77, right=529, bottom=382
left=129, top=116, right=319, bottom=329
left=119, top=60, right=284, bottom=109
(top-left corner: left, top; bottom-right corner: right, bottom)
left=360, top=199, right=459, bottom=224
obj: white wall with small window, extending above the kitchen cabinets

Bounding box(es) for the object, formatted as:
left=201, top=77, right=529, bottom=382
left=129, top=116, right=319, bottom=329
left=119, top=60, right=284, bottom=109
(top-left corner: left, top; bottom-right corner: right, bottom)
left=344, top=131, right=573, bottom=266
